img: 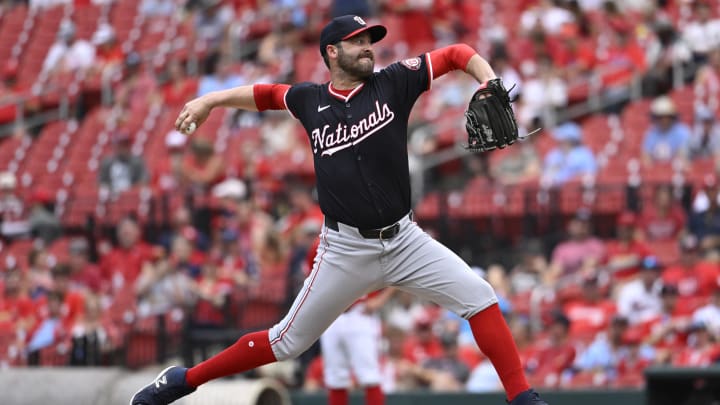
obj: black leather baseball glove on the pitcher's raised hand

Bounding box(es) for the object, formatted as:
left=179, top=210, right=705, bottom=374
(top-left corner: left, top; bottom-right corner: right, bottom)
left=465, top=78, right=518, bottom=152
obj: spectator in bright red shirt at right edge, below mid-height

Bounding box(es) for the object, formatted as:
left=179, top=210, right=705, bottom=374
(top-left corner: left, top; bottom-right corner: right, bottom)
left=662, top=234, right=720, bottom=298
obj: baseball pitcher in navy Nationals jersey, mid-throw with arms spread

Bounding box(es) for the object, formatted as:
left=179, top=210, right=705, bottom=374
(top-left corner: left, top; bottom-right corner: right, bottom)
left=131, top=15, right=547, bottom=405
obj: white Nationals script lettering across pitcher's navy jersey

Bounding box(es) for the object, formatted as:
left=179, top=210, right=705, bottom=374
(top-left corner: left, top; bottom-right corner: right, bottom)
left=310, top=101, right=395, bottom=156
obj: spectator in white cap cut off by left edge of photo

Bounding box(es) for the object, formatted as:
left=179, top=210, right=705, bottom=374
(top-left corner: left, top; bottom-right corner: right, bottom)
left=0, top=172, right=29, bottom=239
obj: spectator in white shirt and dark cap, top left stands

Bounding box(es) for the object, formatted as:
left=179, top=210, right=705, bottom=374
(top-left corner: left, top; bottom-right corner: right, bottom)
left=41, top=19, right=95, bottom=75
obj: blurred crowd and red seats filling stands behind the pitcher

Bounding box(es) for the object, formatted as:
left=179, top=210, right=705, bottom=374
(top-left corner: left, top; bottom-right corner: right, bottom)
left=0, top=0, right=720, bottom=392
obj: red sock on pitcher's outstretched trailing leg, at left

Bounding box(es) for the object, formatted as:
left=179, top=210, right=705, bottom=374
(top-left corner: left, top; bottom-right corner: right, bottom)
left=185, top=330, right=277, bottom=387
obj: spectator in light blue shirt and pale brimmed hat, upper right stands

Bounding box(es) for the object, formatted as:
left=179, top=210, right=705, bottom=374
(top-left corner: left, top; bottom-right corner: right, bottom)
left=642, top=96, right=690, bottom=166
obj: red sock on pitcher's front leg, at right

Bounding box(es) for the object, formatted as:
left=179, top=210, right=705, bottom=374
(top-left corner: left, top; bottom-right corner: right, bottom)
left=469, top=304, right=530, bottom=400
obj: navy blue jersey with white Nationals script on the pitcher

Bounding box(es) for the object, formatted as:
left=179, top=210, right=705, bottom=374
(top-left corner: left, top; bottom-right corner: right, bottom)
left=285, top=54, right=432, bottom=229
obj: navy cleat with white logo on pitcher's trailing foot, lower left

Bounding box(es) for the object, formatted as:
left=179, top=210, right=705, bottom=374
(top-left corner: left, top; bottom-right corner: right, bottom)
left=130, top=366, right=196, bottom=405
